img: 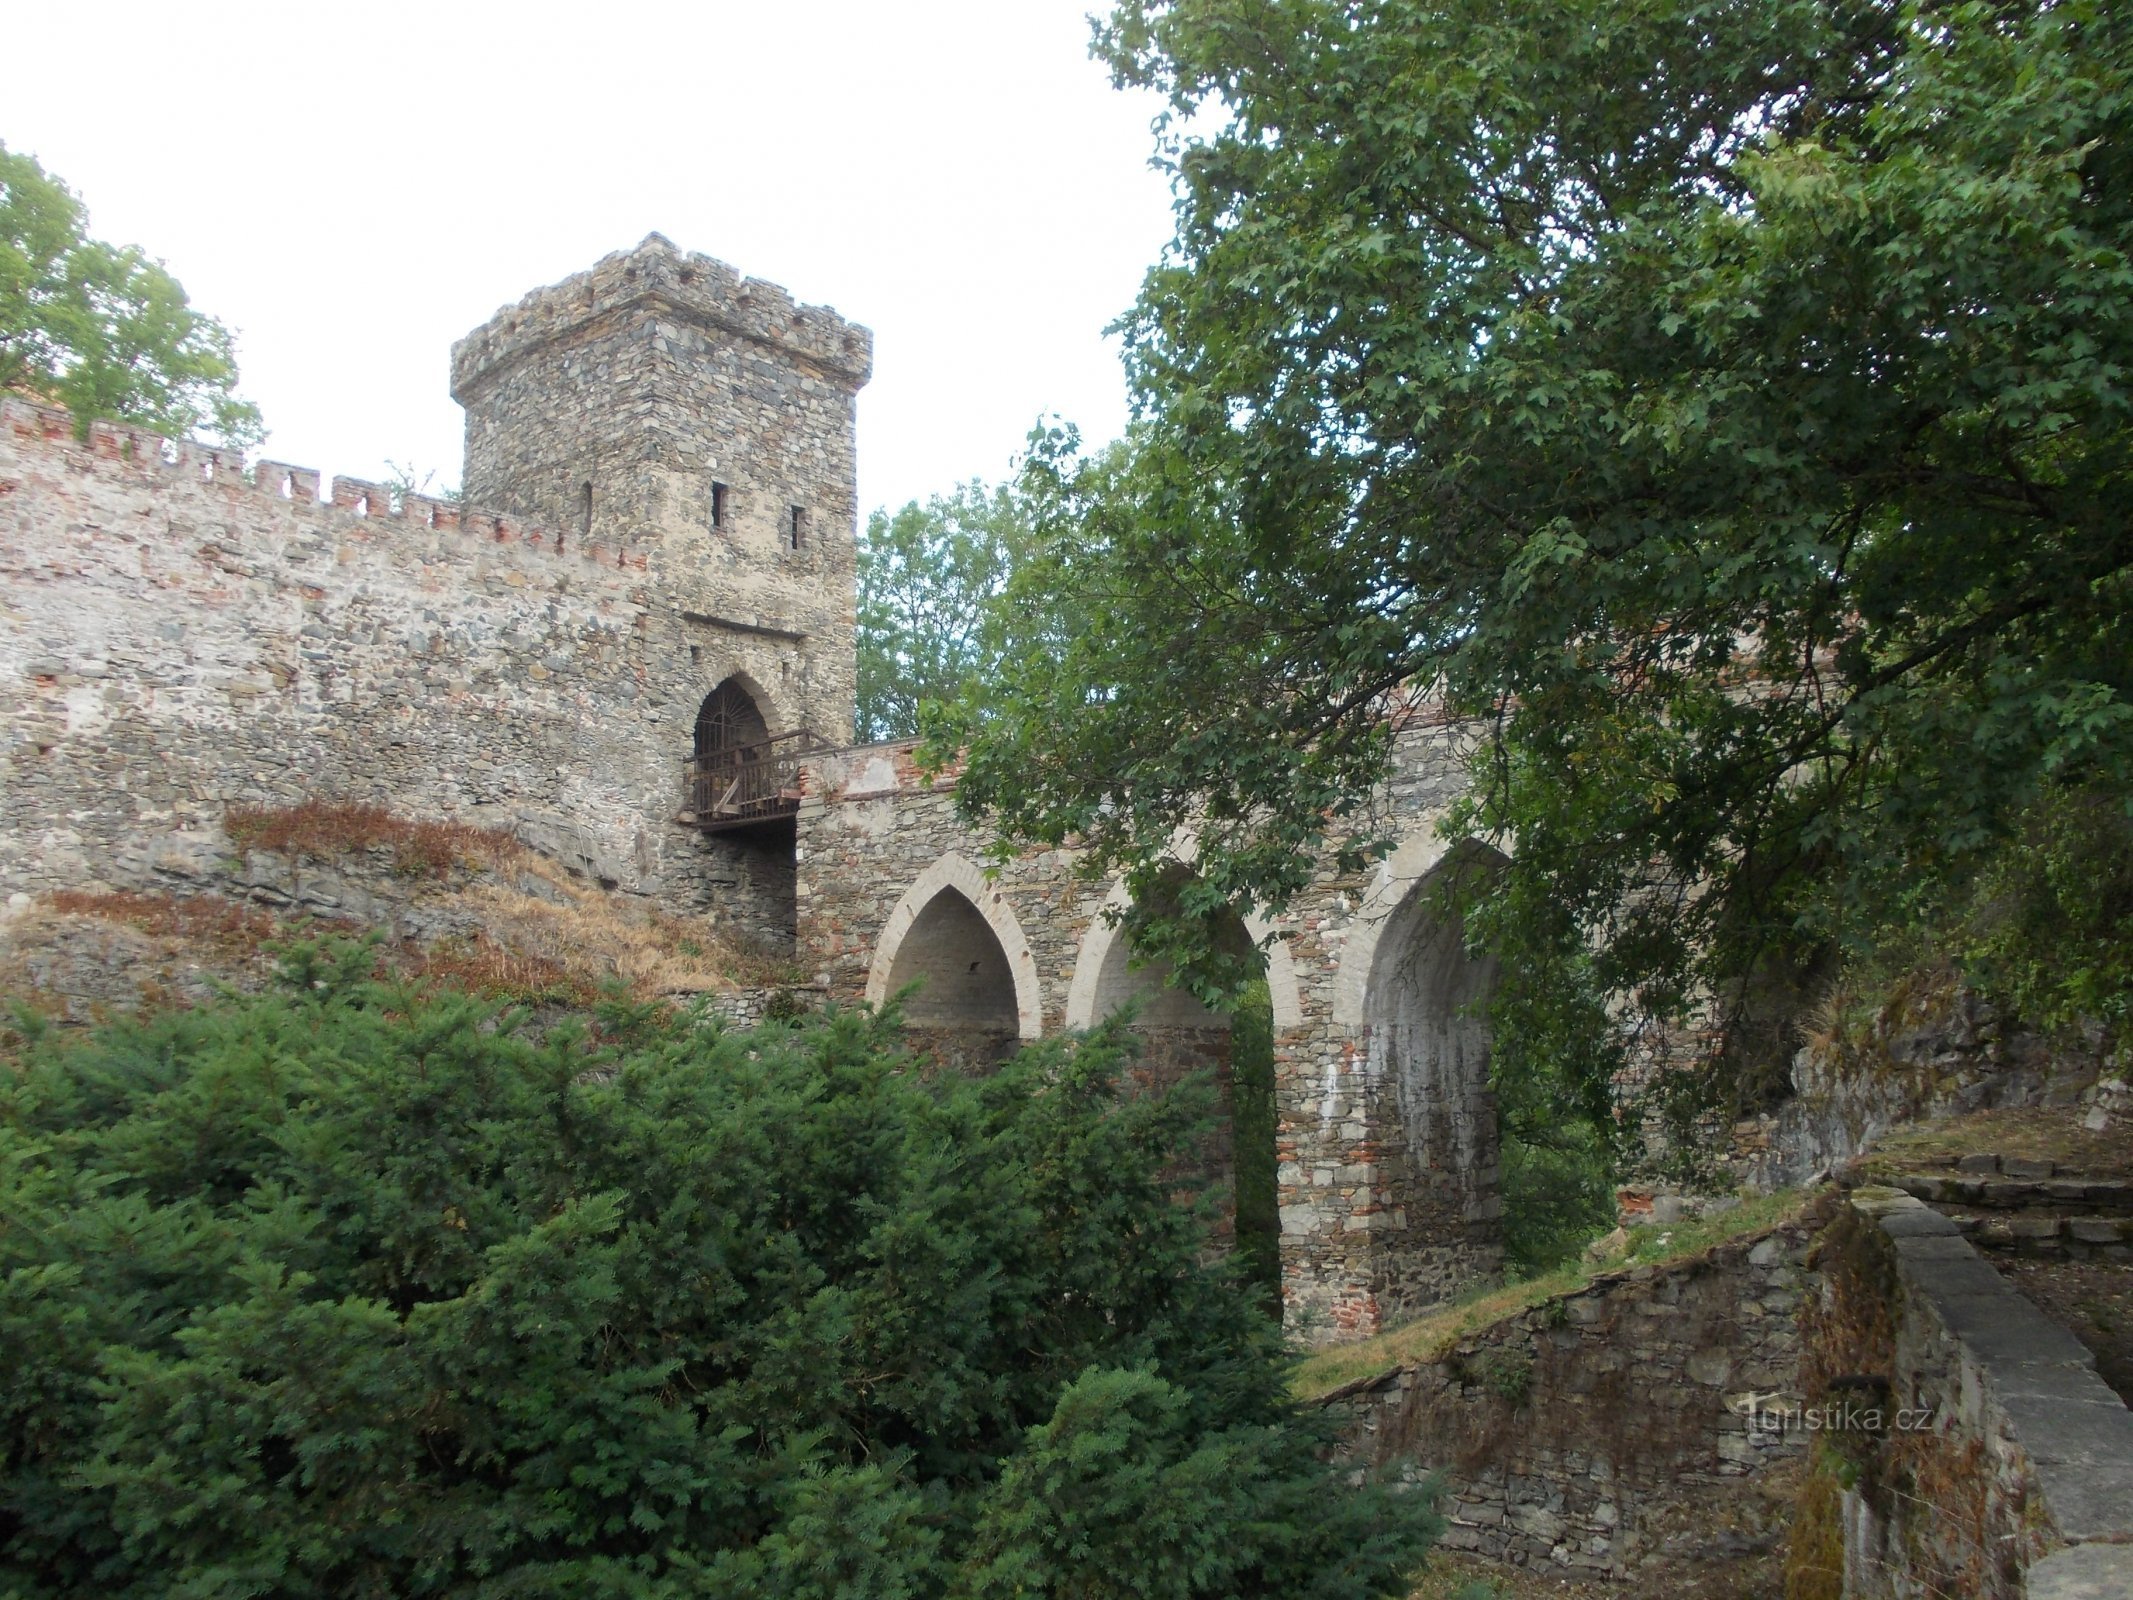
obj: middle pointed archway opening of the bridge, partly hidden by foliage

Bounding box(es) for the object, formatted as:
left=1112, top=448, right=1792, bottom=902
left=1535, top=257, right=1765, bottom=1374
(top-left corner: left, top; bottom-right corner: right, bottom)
left=1090, top=864, right=1282, bottom=1310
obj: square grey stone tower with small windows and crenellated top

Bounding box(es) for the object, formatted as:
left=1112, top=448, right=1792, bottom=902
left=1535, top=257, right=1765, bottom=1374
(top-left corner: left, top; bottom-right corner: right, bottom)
left=452, top=235, right=872, bottom=742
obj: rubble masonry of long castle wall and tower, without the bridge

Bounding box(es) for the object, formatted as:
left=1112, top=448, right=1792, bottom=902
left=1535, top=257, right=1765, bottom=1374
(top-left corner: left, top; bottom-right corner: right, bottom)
left=0, top=237, right=870, bottom=943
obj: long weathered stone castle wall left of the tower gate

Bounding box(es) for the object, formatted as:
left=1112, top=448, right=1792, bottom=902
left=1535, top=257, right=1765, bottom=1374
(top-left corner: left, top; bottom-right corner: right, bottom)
left=0, top=399, right=789, bottom=951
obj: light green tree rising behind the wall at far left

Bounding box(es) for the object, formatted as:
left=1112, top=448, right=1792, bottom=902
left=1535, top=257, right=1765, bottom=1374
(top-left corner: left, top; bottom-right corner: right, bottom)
left=0, top=145, right=264, bottom=448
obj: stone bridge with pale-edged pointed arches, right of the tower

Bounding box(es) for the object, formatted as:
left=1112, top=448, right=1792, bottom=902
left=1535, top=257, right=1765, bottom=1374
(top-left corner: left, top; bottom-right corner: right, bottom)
left=793, top=725, right=1502, bottom=1344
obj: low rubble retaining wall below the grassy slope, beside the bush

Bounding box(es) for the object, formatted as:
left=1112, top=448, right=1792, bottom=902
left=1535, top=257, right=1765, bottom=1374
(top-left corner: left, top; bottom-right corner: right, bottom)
left=1329, top=1218, right=1815, bottom=1579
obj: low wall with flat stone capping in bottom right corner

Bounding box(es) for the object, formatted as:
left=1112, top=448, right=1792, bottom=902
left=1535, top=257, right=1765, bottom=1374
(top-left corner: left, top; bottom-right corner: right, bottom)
left=1802, top=1188, right=2133, bottom=1600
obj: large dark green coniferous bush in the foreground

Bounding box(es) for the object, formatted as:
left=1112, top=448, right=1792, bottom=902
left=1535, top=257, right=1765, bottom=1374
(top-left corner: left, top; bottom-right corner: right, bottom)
left=0, top=947, right=1431, bottom=1600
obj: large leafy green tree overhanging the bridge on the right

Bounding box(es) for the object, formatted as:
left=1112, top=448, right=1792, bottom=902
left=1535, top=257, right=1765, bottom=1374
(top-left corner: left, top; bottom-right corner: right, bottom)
left=936, top=0, right=2133, bottom=1126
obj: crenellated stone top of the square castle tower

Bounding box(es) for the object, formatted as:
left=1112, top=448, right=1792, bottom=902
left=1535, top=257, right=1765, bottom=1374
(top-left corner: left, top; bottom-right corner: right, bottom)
left=452, top=233, right=875, bottom=405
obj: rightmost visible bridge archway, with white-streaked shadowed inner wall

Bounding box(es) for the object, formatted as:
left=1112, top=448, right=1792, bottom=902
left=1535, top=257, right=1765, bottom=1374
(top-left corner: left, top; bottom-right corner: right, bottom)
left=1365, top=841, right=1504, bottom=1308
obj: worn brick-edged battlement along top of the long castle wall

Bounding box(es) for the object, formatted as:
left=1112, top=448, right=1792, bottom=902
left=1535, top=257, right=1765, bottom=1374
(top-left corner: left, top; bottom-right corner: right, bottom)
left=0, top=395, right=646, bottom=572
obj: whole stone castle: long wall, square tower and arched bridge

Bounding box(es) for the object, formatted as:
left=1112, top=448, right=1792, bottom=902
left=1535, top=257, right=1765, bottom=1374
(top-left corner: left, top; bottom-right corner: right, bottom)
left=0, top=237, right=1535, bottom=1340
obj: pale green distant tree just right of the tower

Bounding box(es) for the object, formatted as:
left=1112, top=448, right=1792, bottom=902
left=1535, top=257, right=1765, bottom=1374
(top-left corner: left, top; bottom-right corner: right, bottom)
left=857, top=480, right=1030, bottom=738
